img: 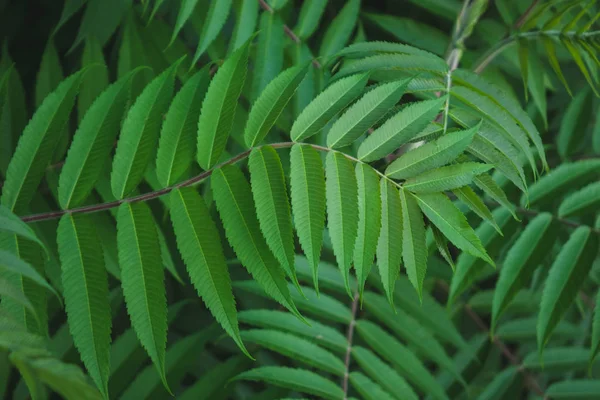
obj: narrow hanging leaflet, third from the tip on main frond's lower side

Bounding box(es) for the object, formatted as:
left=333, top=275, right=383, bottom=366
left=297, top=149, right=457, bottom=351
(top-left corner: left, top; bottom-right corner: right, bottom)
left=377, top=179, right=404, bottom=305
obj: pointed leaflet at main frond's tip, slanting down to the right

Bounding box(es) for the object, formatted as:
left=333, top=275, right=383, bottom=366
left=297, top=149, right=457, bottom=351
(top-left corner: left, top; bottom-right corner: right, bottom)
left=415, top=193, right=495, bottom=266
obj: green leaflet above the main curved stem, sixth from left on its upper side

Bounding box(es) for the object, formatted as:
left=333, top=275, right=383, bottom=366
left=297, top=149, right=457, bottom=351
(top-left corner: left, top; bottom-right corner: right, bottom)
left=244, top=65, right=309, bottom=147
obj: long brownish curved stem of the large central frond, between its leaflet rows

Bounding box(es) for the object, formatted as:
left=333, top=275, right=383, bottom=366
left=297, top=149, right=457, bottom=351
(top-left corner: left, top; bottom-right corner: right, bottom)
left=21, top=142, right=401, bottom=222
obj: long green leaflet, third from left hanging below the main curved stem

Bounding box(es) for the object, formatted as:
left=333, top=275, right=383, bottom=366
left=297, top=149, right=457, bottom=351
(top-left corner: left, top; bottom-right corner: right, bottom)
left=171, top=188, right=250, bottom=357
